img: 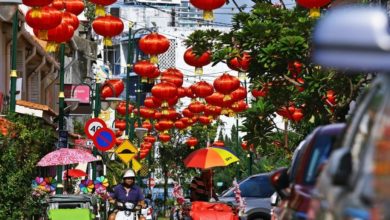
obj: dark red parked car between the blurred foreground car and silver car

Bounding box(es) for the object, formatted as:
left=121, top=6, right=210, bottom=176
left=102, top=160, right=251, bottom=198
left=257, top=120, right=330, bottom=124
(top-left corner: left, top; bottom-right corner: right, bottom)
left=271, top=123, right=345, bottom=220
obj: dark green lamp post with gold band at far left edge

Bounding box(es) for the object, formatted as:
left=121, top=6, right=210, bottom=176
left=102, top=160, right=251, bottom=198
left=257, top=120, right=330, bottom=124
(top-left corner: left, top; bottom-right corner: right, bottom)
left=0, top=0, right=22, bottom=112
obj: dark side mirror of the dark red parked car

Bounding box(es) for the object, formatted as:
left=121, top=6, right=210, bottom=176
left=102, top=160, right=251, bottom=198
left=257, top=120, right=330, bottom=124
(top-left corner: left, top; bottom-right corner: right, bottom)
left=270, top=167, right=290, bottom=199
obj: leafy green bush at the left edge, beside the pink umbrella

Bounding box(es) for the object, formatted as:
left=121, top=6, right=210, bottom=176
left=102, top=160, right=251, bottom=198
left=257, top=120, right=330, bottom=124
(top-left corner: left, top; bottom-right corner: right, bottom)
left=0, top=115, right=56, bottom=219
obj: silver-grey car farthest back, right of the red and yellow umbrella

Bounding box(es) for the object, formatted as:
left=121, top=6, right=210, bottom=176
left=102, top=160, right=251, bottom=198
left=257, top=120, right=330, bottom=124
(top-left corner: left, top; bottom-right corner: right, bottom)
left=219, top=173, right=274, bottom=220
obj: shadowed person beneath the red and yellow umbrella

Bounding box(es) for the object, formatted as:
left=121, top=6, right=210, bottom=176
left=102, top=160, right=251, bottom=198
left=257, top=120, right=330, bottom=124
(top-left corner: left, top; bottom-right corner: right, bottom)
left=190, top=169, right=218, bottom=202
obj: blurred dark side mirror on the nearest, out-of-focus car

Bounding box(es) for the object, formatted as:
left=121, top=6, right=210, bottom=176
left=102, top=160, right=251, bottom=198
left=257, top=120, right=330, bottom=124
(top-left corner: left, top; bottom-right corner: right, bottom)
left=329, top=147, right=352, bottom=186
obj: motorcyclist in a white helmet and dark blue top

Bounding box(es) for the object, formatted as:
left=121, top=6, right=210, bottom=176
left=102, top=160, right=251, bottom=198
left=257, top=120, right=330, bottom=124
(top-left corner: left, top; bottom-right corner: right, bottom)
left=108, top=169, right=146, bottom=220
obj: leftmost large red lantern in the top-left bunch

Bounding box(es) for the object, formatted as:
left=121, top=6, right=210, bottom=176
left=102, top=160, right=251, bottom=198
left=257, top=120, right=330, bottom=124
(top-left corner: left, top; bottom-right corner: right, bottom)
left=25, top=6, right=62, bottom=40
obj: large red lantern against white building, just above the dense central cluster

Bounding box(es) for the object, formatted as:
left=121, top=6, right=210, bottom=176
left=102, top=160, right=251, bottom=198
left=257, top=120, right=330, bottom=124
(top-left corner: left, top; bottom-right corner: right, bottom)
left=138, top=32, right=170, bottom=63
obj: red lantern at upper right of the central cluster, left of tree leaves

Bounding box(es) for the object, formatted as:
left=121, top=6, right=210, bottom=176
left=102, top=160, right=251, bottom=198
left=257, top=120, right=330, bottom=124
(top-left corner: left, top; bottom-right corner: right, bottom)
left=214, top=73, right=240, bottom=100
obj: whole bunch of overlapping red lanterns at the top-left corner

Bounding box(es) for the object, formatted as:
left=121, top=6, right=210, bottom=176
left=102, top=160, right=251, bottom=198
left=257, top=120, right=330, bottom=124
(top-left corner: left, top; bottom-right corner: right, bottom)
left=23, top=0, right=84, bottom=52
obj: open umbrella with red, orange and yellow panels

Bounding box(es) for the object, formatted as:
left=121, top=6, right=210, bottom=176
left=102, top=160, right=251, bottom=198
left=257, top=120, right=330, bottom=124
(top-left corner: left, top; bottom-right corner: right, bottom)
left=184, top=147, right=239, bottom=169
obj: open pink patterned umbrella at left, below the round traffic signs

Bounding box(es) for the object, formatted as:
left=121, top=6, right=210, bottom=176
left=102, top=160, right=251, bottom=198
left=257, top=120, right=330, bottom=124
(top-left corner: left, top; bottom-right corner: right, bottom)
left=37, top=148, right=98, bottom=167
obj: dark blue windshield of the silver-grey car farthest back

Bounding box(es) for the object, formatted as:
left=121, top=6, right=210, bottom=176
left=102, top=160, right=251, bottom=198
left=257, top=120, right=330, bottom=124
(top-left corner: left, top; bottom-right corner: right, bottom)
left=222, top=175, right=274, bottom=198
